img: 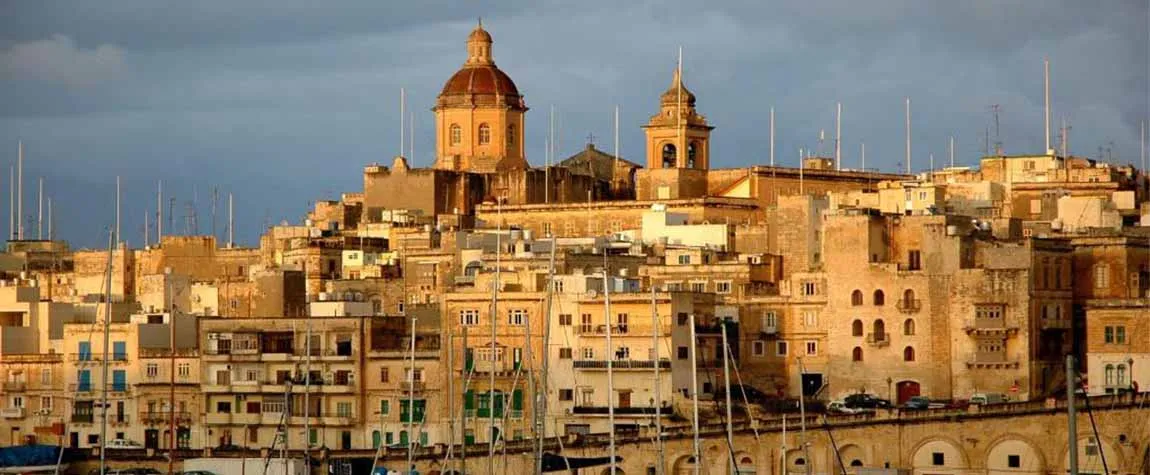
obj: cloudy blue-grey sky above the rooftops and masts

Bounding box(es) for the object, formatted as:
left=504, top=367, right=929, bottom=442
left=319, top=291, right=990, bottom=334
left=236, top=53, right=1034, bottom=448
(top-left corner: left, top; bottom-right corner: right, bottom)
left=0, top=0, right=1150, bottom=247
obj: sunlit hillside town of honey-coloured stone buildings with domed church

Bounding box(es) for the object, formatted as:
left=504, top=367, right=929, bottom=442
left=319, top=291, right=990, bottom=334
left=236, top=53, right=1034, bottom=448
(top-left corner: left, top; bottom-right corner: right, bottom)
left=0, top=21, right=1150, bottom=475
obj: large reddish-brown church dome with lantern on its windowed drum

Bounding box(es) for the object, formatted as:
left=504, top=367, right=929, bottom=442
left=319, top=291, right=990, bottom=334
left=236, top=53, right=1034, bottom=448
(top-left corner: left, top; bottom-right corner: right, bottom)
left=432, top=23, right=527, bottom=173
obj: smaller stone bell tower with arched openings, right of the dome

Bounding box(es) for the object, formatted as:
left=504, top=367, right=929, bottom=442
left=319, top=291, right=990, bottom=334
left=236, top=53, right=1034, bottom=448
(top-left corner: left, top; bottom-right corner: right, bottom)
left=643, top=68, right=714, bottom=170
